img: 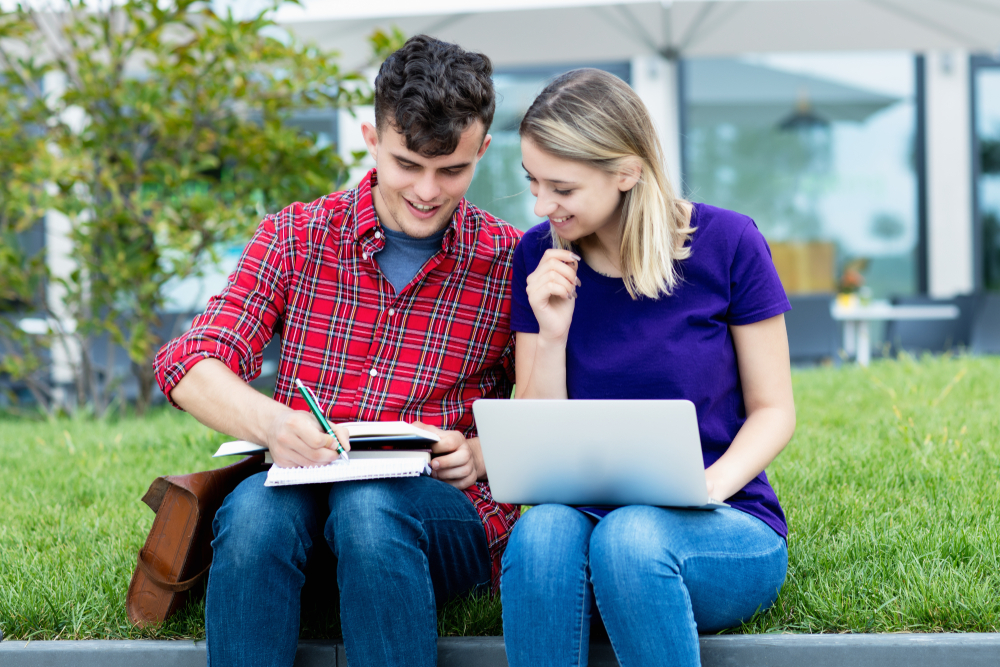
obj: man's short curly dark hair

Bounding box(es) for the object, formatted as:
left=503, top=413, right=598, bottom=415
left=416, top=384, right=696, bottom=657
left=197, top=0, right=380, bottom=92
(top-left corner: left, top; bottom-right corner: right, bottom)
left=375, top=35, right=496, bottom=157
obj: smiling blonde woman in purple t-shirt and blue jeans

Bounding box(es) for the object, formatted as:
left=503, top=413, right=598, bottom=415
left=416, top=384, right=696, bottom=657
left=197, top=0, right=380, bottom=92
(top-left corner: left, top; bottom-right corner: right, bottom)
left=501, top=69, right=795, bottom=667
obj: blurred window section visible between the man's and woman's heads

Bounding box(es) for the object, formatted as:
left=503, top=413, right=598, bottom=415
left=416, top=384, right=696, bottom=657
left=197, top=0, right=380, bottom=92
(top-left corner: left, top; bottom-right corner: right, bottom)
left=466, top=63, right=631, bottom=230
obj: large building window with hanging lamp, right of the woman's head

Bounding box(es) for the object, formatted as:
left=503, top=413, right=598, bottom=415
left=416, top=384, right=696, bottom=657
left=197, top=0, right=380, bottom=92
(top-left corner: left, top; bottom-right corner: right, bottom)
left=682, top=53, right=920, bottom=297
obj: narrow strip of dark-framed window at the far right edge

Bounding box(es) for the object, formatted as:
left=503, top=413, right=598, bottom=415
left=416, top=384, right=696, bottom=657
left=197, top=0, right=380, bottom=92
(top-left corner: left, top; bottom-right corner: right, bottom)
left=972, top=56, right=1000, bottom=291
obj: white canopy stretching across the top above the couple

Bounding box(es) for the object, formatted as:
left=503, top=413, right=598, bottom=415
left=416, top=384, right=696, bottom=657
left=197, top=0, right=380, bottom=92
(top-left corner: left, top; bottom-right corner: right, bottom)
left=279, top=0, right=1000, bottom=67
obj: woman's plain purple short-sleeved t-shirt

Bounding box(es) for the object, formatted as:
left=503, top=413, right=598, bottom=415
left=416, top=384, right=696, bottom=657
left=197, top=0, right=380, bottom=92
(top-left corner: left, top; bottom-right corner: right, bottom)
left=510, top=204, right=791, bottom=537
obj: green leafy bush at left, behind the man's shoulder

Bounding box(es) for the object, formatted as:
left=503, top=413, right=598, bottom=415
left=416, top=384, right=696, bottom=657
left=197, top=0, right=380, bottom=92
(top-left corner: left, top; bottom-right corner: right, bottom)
left=0, top=0, right=370, bottom=412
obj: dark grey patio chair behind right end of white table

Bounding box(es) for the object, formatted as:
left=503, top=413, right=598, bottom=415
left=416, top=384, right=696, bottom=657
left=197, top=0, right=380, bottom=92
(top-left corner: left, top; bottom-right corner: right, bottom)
left=885, top=294, right=980, bottom=354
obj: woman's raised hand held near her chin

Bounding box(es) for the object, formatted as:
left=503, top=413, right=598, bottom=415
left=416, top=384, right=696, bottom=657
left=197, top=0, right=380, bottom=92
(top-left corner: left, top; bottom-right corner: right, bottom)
left=527, top=249, right=580, bottom=341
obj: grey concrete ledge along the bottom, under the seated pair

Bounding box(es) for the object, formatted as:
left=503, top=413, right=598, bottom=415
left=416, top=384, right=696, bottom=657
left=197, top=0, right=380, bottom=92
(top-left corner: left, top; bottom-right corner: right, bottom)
left=0, top=633, right=1000, bottom=667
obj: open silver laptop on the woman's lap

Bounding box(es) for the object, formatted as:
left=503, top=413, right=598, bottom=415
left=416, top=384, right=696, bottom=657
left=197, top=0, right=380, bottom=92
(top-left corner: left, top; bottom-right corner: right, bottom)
left=472, top=399, right=728, bottom=509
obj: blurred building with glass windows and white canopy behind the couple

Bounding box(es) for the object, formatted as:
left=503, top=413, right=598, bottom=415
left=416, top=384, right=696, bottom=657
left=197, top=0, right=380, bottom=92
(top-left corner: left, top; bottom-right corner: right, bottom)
left=256, top=0, right=1000, bottom=298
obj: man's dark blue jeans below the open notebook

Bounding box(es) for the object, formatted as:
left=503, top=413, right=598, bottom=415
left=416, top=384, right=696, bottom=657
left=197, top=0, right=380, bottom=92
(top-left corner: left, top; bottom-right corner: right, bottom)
left=205, top=473, right=490, bottom=667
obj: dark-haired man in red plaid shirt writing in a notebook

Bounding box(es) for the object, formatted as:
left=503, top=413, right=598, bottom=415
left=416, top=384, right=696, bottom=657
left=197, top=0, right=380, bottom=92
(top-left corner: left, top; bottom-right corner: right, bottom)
left=155, top=36, right=519, bottom=667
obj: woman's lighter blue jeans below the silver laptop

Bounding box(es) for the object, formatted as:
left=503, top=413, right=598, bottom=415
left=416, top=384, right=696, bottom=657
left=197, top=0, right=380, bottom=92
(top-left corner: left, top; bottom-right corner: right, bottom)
left=500, top=505, right=788, bottom=667
